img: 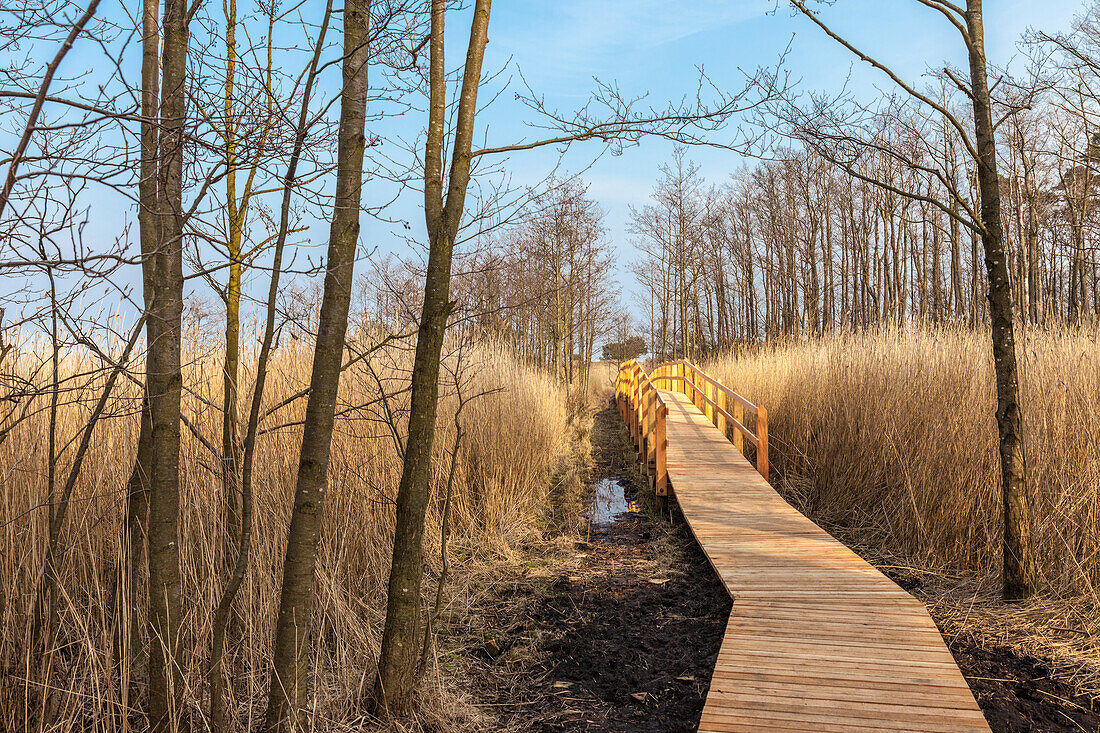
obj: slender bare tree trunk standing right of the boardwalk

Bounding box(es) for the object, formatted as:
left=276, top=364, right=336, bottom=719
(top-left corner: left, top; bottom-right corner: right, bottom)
left=966, top=0, right=1034, bottom=600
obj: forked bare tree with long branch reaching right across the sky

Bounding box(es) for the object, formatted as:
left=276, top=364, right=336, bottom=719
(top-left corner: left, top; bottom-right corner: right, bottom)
left=373, top=0, right=778, bottom=718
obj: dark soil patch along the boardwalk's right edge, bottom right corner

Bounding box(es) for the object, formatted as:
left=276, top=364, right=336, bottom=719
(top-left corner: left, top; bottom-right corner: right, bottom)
left=883, top=569, right=1100, bottom=733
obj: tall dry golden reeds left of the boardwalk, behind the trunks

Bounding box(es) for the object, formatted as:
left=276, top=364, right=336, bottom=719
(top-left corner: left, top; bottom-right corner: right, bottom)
left=0, top=339, right=568, bottom=731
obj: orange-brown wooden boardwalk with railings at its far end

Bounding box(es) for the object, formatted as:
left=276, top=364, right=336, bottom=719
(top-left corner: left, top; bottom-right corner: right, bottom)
left=616, top=361, right=989, bottom=733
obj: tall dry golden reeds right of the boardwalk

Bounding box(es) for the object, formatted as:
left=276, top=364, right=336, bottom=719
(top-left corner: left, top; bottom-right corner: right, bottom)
left=708, top=328, right=1100, bottom=597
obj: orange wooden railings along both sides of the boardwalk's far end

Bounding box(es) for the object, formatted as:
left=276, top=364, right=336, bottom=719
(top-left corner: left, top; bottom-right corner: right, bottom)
left=615, top=359, right=769, bottom=484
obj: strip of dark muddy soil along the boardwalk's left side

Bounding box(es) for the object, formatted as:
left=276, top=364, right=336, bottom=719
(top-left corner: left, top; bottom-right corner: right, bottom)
left=480, top=408, right=730, bottom=733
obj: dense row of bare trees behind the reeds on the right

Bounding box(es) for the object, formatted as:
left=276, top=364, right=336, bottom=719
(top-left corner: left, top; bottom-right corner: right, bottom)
left=631, top=6, right=1100, bottom=358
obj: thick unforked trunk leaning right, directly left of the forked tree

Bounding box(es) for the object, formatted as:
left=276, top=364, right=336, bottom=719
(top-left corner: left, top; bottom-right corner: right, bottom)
left=260, top=0, right=371, bottom=733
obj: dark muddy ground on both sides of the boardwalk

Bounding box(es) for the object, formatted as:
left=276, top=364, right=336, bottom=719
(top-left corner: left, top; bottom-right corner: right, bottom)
left=472, top=400, right=1100, bottom=733
